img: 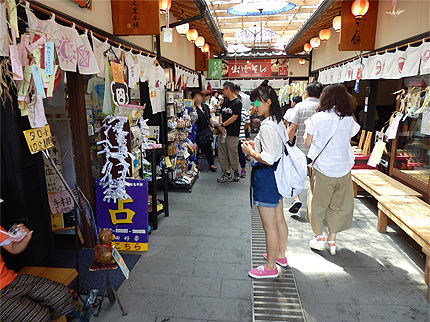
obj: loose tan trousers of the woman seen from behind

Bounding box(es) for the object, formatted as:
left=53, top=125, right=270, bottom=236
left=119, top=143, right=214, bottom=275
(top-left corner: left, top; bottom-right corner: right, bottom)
left=307, top=169, right=354, bottom=235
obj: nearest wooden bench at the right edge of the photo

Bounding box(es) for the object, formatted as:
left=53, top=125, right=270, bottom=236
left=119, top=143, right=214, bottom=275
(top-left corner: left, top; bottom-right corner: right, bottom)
left=377, top=196, right=430, bottom=303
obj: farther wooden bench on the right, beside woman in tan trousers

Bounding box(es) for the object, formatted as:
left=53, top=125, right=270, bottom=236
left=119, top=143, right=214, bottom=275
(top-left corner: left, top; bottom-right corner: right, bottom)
left=351, top=169, right=422, bottom=198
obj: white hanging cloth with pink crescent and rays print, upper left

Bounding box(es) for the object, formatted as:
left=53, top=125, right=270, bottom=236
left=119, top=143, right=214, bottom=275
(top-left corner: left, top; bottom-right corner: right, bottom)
left=52, top=21, right=79, bottom=72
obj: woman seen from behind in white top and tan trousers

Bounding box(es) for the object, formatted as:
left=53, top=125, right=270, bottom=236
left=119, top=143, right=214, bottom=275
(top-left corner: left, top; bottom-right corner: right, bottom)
left=304, top=84, right=360, bottom=255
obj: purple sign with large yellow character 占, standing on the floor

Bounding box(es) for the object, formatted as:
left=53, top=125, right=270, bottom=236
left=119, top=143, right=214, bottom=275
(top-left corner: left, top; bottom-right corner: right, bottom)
left=96, top=179, right=148, bottom=251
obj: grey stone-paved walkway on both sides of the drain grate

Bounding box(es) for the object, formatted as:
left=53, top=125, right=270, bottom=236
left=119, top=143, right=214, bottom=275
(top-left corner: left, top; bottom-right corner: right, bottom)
left=99, top=166, right=430, bottom=322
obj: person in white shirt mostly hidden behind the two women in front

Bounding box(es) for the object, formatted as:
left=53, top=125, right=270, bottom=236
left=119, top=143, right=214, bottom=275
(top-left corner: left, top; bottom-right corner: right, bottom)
left=284, top=83, right=322, bottom=214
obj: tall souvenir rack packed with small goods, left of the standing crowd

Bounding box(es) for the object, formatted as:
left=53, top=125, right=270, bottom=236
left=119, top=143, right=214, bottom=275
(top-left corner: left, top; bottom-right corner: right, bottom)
left=166, top=91, right=198, bottom=192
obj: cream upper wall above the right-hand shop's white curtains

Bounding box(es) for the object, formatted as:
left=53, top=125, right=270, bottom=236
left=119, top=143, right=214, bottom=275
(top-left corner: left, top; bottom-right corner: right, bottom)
left=312, top=0, right=430, bottom=70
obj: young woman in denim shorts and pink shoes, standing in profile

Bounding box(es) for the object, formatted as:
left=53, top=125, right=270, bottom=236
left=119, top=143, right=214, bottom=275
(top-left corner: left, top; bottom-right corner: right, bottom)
left=242, top=81, right=288, bottom=278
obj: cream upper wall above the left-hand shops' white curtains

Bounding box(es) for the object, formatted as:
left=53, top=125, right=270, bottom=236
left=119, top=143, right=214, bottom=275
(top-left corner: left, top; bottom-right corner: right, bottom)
left=39, top=0, right=195, bottom=69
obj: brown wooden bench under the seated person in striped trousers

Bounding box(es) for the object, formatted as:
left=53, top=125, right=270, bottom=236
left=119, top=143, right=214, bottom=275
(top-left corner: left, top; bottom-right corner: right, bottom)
left=19, top=266, right=78, bottom=322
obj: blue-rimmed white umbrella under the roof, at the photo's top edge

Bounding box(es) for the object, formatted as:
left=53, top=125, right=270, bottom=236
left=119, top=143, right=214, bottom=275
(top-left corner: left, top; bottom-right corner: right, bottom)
left=227, top=0, right=296, bottom=16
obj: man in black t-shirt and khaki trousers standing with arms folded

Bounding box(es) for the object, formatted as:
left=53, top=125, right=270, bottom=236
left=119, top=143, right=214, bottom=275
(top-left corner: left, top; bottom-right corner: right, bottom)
left=218, top=82, right=242, bottom=182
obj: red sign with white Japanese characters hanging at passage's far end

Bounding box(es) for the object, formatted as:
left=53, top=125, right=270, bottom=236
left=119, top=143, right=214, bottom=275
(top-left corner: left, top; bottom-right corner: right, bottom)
left=228, top=59, right=272, bottom=78
